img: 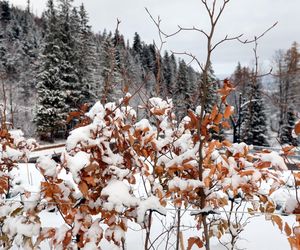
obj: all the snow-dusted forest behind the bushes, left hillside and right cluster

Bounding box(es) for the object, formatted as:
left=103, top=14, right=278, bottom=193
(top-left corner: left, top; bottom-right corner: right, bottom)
left=0, top=0, right=300, bottom=146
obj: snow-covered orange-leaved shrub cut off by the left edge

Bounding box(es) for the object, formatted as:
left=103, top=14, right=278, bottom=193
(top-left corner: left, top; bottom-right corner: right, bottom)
left=0, top=129, right=40, bottom=249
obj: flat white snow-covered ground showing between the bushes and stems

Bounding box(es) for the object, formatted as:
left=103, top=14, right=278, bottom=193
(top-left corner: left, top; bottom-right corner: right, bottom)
left=9, top=164, right=294, bottom=250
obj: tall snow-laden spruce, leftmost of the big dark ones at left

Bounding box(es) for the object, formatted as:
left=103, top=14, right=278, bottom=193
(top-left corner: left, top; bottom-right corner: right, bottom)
left=34, top=0, right=66, bottom=140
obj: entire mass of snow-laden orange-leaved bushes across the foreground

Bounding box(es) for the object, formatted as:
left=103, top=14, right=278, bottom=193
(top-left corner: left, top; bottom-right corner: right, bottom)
left=0, top=87, right=297, bottom=249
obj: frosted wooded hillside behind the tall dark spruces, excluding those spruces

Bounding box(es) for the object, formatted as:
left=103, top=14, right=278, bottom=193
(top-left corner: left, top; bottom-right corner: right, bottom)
left=0, top=1, right=204, bottom=135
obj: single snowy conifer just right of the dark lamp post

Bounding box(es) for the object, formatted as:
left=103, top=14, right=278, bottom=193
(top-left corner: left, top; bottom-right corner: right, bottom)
left=241, top=76, right=269, bottom=146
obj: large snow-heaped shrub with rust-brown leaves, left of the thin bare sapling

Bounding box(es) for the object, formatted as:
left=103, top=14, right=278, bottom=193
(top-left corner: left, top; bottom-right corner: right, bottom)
left=37, top=94, right=171, bottom=248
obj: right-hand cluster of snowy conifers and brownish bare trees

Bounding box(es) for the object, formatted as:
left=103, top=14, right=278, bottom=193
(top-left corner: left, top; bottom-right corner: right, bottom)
left=231, top=42, right=300, bottom=146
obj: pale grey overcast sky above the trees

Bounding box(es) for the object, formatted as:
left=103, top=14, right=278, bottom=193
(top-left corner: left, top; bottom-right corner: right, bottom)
left=10, top=0, right=300, bottom=76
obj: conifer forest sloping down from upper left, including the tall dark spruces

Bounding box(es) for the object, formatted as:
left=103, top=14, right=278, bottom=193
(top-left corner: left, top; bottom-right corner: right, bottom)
left=0, top=0, right=205, bottom=139
